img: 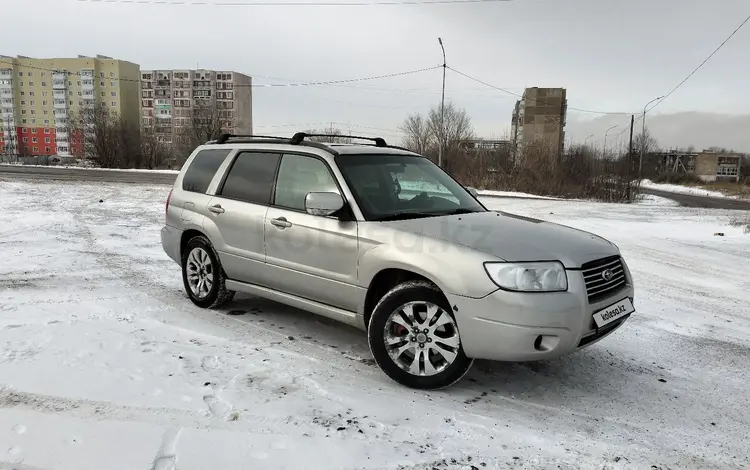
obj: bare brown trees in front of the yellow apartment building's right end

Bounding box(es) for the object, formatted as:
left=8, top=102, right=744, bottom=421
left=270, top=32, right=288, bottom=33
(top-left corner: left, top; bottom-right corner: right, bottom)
left=70, top=106, right=141, bottom=168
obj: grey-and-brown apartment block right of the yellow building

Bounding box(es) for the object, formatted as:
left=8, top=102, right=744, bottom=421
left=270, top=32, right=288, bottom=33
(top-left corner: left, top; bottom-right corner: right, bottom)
left=141, top=69, right=253, bottom=143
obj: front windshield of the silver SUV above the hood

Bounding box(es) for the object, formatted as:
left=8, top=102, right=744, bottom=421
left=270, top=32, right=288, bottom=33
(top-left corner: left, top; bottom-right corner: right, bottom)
left=336, top=154, right=486, bottom=220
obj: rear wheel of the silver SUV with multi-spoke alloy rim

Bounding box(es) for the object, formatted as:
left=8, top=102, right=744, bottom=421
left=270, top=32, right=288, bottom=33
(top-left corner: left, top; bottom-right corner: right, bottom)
left=182, top=235, right=235, bottom=308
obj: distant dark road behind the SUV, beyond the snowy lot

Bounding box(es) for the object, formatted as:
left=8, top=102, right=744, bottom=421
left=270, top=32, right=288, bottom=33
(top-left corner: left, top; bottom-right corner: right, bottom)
left=0, top=165, right=750, bottom=210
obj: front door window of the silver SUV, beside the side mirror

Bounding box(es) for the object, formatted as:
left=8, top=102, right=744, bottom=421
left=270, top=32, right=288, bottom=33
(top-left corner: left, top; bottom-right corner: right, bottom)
left=274, top=155, right=339, bottom=211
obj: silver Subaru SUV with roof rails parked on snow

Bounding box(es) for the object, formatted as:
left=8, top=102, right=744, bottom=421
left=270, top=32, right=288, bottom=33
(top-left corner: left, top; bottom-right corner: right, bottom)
left=161, top=133, right=634, bottom=389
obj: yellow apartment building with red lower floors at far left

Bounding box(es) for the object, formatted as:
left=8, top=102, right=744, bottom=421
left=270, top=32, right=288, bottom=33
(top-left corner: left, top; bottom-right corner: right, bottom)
left=0, top=55, right=140, bottom=157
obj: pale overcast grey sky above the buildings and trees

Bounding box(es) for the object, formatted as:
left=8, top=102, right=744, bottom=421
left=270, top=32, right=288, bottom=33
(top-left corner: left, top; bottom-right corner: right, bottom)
left=5, top=0, right=750, bottom=151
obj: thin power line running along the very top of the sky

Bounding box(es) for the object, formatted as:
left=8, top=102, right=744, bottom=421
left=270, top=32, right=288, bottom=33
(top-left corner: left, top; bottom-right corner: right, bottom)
left=77, top=0, right=513, bottom=7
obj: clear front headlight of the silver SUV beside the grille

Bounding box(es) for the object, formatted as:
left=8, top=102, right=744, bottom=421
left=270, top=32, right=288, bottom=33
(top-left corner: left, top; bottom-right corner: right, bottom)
left=484, top=261, right=568, bottom=292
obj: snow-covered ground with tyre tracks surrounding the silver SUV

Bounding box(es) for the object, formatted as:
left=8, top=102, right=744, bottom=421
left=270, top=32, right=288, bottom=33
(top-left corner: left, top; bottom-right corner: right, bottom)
left=0, top=182, right=750, bottom=470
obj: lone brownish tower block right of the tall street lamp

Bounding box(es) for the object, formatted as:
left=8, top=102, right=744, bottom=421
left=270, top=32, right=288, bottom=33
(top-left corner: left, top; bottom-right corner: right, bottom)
left=511, top=87, right=568, bottom=160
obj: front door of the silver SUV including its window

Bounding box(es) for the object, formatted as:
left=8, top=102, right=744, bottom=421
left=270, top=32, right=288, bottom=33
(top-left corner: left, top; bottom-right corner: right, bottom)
left=265, top=154, right=359, bottom=311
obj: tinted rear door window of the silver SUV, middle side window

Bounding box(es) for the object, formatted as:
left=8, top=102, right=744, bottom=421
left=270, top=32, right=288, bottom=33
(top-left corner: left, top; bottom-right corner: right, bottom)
left=220, top=152, right=281, bottom=204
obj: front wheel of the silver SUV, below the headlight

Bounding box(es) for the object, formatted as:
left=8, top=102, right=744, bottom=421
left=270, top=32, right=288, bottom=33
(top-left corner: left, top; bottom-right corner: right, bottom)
left=367, top=281, right=474, bottom=390
